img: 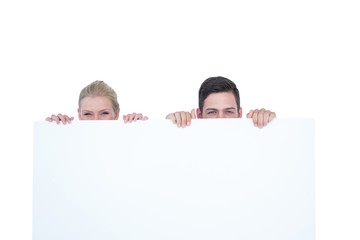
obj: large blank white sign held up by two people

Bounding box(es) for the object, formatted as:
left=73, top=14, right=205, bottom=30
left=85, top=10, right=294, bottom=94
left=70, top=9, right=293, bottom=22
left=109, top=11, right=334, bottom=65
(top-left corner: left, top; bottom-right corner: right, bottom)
left=33, top=119, right=315, bottom=240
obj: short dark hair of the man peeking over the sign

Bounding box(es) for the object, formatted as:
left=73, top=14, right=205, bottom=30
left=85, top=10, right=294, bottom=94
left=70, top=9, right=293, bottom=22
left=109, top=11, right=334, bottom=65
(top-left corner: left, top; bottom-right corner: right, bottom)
left=199, top=76, right=240, bottom=112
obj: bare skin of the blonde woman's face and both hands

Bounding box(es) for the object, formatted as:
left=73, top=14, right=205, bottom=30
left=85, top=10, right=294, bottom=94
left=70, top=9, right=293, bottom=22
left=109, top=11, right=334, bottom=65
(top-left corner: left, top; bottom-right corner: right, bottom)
left=45, top=96, right=148, bottom=124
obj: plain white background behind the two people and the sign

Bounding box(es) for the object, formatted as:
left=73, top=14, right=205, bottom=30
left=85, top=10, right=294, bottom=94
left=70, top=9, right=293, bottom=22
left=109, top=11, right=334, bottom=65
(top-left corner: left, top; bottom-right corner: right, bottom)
left=0, top=0, right=360, bottom=240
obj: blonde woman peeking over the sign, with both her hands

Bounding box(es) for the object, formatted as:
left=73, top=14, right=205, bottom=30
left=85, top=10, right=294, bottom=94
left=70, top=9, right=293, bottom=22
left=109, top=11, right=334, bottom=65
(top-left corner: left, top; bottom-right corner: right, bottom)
left=46, top=80, right=148, bottom=124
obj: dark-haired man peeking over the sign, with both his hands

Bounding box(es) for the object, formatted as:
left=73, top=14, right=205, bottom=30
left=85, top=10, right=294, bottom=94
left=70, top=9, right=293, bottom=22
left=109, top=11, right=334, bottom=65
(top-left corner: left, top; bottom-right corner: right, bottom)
left=166, top=77, right=276, bottom=128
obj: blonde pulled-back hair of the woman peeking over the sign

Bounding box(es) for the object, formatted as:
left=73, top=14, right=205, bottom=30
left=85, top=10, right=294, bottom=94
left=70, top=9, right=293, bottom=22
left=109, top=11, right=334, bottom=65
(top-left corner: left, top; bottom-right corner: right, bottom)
left=79, top=80, right=120, bottom=113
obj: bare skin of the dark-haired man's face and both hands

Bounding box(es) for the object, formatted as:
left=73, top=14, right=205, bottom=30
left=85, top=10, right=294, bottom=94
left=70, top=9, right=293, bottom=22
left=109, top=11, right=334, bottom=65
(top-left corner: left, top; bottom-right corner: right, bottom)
left=166, top=92, right=276, bottom=128
